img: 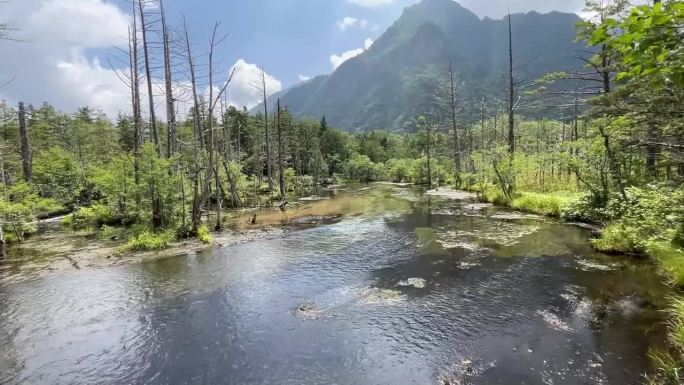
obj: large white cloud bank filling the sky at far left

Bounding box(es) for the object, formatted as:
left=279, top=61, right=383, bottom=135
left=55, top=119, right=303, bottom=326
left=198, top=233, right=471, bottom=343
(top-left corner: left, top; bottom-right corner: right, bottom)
left=0, top=0, right=130, bottom=117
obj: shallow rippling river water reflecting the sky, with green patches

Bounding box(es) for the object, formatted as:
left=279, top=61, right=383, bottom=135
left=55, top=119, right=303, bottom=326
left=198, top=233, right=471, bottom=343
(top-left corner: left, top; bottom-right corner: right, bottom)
left=0, top=186, right=667, bottom=385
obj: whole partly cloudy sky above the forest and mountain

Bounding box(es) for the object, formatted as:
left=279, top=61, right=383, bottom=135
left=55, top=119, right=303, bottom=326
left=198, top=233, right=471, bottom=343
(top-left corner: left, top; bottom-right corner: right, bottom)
left=0, top=0, right=584, bottom=117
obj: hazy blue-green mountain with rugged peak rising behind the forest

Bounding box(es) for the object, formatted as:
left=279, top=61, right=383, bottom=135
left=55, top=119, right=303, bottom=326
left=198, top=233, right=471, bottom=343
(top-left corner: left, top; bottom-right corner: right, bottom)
left=273, top=0, right=581, bottom=131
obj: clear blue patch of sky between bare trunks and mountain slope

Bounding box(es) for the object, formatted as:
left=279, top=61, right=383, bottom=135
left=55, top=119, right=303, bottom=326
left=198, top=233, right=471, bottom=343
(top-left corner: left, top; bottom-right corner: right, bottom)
left=154, top=0, right=415, bottom=86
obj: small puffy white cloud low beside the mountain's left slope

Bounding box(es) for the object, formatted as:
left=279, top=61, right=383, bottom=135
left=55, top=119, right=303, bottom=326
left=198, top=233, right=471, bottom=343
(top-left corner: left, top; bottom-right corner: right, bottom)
left=226, top=59, right=283, bottom=108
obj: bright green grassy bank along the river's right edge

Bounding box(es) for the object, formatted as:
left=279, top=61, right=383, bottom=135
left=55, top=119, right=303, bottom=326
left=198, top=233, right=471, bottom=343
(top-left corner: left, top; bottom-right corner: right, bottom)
left=456, top=184, right=684, bottom=384
